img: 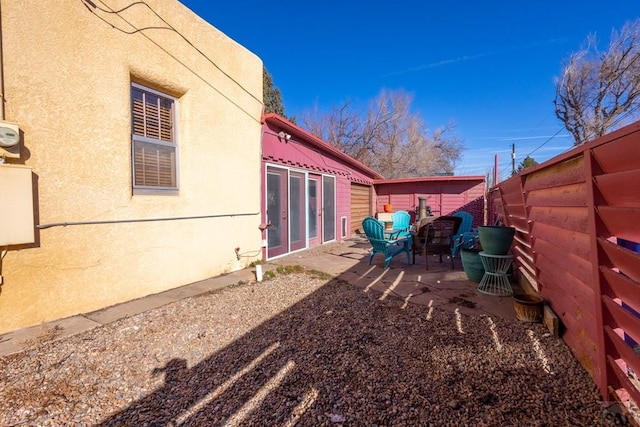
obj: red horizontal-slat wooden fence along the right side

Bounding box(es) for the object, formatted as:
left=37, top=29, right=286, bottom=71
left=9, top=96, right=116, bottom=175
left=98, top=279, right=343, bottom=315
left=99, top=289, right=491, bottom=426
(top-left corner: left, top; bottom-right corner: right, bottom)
left=488, top=122, right=640, bottom=414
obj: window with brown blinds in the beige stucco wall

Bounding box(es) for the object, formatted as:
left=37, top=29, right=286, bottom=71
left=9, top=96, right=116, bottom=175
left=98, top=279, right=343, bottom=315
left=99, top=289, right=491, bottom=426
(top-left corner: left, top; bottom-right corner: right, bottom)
left=131, top=84, right=178, bottom=190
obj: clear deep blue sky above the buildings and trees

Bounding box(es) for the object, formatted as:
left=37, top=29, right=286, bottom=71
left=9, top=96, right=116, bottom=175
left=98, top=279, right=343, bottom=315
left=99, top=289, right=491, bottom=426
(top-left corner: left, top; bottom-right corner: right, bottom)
left=181, top=0, right=640, bottom=178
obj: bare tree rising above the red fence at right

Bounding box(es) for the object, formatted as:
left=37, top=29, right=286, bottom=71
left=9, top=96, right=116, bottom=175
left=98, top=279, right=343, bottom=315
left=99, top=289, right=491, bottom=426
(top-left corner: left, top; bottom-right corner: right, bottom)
left=554, top=18, right=640, bottom=145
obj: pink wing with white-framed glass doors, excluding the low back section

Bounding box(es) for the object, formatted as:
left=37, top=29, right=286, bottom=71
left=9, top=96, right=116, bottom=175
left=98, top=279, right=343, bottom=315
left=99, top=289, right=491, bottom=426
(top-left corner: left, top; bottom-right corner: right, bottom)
left=262, top=114, right=383, bottom=259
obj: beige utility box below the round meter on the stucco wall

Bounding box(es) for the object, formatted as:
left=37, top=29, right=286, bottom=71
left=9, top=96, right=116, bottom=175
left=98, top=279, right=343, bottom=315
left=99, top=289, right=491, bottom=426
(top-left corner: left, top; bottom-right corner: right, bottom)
left=0, top=164, right=35, bottom=247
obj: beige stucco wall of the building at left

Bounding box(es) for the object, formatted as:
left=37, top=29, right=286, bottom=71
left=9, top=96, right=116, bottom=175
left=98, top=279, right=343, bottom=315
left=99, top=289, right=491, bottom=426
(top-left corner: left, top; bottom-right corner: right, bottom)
left=0, top=0, right=262, bottom=333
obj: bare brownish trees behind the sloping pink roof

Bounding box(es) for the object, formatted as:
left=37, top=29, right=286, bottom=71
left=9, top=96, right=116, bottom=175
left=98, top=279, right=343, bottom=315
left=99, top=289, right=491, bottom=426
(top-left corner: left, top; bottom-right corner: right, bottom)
left=302, top=90, right=462, bottom=178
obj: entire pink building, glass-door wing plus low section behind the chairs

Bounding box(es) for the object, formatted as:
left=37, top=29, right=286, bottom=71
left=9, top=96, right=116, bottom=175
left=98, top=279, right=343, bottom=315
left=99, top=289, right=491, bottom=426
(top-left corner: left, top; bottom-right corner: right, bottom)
left=261, top=114, right=485, bottom=259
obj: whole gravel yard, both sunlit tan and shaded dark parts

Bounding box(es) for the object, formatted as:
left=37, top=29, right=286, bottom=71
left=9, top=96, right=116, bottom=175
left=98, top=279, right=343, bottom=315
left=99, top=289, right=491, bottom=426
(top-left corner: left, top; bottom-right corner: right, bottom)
left=0, top=272, right=602, bottom=426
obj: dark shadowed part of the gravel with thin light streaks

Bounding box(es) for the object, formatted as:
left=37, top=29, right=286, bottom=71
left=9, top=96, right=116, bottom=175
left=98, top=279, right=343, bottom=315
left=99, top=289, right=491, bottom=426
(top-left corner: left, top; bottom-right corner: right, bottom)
left=100, top=278, right=600, bottom=426
